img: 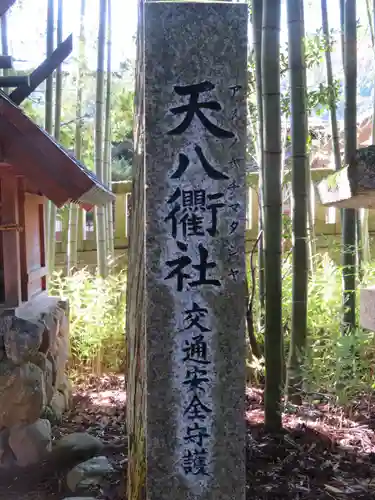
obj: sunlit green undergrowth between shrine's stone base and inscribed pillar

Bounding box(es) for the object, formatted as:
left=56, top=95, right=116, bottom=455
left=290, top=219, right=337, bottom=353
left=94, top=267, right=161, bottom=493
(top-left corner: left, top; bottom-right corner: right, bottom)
left=50, top=269, right=126, bottom=375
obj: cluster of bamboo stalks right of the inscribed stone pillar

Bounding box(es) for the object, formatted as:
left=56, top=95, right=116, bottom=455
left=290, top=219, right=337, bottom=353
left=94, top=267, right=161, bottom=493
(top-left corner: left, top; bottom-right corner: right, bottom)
left=248, top=0, right=364, bottom=431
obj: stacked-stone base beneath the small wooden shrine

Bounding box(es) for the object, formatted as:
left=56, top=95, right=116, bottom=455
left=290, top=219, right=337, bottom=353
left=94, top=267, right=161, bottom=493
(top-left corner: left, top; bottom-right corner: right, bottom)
left=0, top=293, right=71, bottom=468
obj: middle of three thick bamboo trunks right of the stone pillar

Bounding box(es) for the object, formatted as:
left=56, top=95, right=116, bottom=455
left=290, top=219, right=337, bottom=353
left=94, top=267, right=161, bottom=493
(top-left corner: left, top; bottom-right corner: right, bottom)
left=287, top=0, right=312, bottom=404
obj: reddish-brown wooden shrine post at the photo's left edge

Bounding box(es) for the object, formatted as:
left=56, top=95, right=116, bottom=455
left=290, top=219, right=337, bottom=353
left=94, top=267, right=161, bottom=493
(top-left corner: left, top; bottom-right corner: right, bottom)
left=1, top=175, right=21, bottom=307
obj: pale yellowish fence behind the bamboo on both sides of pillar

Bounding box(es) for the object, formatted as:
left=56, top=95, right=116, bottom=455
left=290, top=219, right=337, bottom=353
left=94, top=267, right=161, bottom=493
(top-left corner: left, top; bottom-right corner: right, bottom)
left=56, top=169, right=375, bottom=267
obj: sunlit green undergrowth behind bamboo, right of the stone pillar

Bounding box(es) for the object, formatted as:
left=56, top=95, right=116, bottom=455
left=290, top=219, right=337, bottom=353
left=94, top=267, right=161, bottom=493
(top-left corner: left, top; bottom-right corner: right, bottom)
left=251, top=254, right=375, bottom=405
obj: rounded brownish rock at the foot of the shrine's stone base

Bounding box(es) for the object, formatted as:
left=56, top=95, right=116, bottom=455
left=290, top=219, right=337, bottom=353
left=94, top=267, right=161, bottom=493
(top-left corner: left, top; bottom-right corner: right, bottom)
left=9, top=419, right=51, bottom=467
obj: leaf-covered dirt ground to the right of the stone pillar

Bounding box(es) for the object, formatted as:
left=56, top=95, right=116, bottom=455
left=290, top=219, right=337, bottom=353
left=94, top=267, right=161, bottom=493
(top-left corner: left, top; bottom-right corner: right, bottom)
left=246, top=389, right=375, bottom=500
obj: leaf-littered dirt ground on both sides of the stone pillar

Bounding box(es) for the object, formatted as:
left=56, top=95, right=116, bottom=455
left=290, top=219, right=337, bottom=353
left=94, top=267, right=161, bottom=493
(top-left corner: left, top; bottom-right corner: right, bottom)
left=0, top=375, right=375, bottom=500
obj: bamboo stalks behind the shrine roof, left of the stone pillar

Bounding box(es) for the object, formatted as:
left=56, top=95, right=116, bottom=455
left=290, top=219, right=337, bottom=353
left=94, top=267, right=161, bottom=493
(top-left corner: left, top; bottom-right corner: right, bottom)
left=42, top=0, right=114, bottom=277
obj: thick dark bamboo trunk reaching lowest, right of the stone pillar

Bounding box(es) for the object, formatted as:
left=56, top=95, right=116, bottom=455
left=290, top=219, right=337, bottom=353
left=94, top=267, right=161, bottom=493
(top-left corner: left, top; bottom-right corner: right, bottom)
left=262, top=0, right=283, bottom=431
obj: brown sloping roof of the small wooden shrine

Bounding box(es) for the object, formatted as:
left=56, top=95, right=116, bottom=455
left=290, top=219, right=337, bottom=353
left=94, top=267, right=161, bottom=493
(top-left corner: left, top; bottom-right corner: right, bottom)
left=0, top=90, right=115, bottom=210
